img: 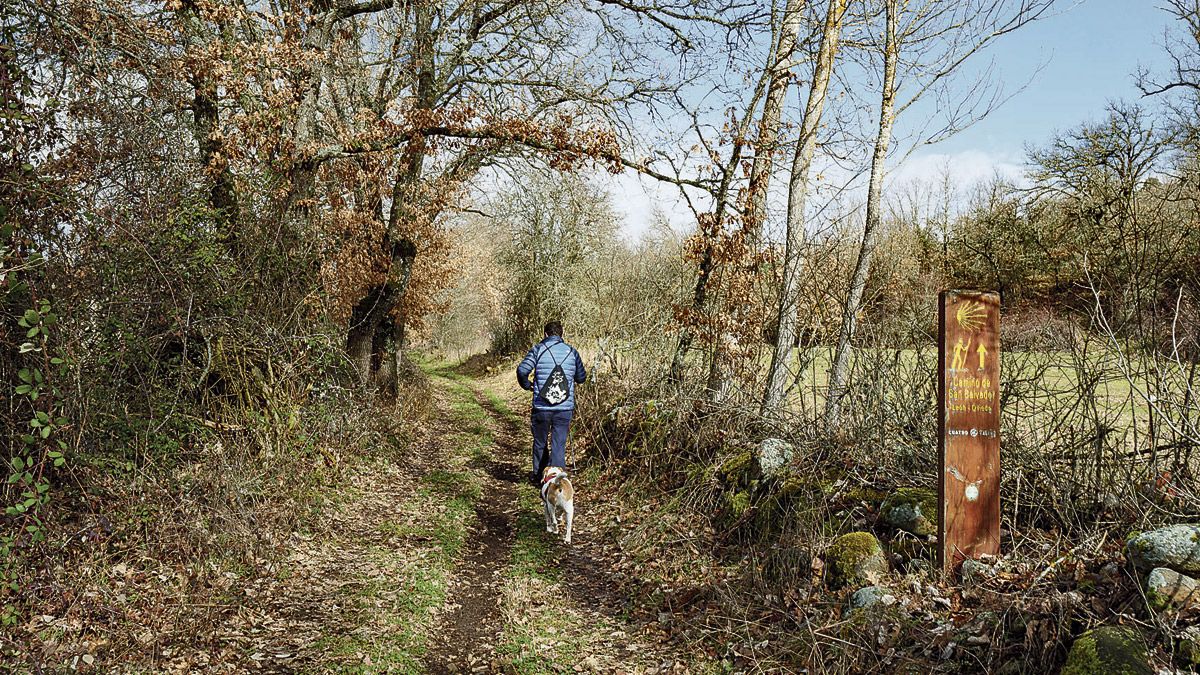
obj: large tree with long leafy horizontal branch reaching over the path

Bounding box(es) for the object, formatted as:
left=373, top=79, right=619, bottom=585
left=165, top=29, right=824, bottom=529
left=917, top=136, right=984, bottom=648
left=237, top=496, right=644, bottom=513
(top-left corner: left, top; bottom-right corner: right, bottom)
left=286, top=0, right=742, bottom=383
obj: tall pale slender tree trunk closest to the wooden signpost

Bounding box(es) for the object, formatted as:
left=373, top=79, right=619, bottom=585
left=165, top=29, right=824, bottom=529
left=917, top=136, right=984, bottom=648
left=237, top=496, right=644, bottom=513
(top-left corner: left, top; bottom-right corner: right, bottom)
left=826, top=0, right=899, bottom=426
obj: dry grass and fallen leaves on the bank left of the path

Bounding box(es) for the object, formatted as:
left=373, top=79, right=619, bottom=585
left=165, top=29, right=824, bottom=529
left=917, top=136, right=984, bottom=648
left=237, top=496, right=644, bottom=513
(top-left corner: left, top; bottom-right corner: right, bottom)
left=0, top=357, right=432, bottom=673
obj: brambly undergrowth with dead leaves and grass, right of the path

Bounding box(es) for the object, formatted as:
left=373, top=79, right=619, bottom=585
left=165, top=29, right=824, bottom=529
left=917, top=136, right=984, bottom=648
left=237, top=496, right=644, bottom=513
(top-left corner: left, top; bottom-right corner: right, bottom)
left=559, top=355, right=1196, bottom=673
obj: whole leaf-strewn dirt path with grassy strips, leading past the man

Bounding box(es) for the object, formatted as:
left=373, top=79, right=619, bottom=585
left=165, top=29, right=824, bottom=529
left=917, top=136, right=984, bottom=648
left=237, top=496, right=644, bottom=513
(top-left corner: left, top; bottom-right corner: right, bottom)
left=225, top=366, right=707, bottom=675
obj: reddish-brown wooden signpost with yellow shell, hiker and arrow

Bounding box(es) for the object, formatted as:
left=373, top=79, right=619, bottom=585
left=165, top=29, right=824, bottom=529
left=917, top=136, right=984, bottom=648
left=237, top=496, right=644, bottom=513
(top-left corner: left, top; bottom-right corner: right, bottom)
left=937, top=285, right=1000, bottom=571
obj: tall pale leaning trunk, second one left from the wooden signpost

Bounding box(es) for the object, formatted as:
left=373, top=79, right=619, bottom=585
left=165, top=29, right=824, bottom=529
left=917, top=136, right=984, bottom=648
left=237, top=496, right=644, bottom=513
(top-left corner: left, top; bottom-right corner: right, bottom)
left=762, top=0, right=847, bottom=416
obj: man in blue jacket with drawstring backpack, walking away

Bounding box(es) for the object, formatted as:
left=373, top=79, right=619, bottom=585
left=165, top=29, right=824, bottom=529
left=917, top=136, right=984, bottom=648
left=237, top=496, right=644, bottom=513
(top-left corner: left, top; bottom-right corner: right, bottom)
left=517, top=321, right=588, bottom=485
